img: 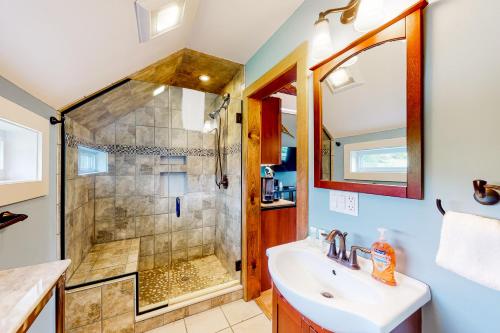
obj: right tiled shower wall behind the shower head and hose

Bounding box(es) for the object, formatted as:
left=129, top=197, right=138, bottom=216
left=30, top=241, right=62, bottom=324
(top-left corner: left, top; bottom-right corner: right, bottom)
left=215, top=70, right=244, bottom=279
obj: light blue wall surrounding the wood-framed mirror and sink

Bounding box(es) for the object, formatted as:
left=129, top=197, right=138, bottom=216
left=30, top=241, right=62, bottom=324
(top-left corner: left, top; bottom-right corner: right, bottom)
left=246, top=0, right=500, bottom=333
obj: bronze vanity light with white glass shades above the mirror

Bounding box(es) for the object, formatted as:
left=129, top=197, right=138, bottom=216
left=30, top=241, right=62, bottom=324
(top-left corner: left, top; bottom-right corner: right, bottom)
left=312, top=0, right=384, bottom=61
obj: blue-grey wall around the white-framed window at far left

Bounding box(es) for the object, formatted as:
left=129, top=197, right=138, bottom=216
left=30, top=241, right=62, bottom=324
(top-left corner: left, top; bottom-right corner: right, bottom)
left=0, top=76, right=58, bottom=333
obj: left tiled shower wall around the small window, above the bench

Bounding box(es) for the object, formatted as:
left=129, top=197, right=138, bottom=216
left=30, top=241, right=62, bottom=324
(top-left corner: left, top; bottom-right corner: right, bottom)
left=65, top=119, right=95, bottom=278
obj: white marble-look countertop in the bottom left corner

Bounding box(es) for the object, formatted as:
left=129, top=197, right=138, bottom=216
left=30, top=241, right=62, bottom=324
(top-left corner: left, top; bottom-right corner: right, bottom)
left=0, top=260, right=71, bottom=333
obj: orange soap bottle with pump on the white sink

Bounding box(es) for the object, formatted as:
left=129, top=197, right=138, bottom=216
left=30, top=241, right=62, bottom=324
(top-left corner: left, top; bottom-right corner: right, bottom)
left=372, top=228, right=396, bottom=286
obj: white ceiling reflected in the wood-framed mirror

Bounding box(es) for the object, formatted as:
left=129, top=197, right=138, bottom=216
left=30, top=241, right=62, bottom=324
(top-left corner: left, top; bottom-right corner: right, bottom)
left=322, top=41, right=406, bottom=138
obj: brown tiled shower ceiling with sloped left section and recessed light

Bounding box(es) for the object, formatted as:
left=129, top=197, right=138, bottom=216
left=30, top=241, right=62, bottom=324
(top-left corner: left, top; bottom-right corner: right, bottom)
left=66, top=49, right=243, bottom=131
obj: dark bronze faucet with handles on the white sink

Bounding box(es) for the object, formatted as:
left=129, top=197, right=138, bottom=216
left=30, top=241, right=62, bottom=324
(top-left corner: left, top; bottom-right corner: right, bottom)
left=322, top=229, right=372, bottom=269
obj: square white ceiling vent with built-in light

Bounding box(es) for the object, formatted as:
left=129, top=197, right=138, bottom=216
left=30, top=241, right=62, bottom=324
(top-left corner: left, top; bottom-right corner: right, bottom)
left=135, top=0, right=186, bottom=43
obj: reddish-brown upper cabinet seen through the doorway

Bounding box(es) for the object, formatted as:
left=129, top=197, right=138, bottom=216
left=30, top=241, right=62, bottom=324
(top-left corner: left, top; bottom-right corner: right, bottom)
left=260, top=97, right=281, bottom=165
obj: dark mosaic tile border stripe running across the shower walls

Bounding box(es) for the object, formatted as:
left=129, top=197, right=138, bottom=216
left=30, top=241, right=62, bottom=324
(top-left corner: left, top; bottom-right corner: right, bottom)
left=66, top=134, right=241, bottom=157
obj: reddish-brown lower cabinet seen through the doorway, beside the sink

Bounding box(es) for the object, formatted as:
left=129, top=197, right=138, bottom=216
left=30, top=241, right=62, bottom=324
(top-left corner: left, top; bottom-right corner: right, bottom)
left=260, top=207, right=297, bottom=291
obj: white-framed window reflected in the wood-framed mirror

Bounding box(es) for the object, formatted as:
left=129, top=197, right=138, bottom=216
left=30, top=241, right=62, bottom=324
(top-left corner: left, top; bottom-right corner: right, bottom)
left=344, top=138, right=408, bottom=182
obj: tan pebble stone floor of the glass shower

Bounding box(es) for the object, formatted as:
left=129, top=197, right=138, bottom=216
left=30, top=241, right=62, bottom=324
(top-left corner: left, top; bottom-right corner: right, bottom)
left=139, top=255, right=233, bottom=307
